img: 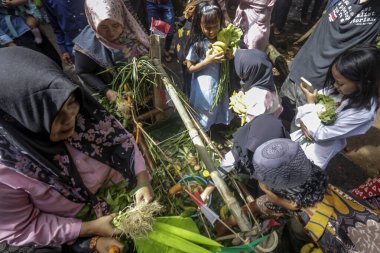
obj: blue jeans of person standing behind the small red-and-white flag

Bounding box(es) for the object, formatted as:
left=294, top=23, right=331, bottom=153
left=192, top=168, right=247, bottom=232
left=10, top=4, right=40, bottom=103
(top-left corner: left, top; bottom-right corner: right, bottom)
left=146, top=0, right=174, bottom=51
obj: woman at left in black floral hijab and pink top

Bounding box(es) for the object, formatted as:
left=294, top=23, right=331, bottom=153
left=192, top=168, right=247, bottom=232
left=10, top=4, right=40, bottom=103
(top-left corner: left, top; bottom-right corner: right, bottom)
left=0, top=47, right=153, bottom=252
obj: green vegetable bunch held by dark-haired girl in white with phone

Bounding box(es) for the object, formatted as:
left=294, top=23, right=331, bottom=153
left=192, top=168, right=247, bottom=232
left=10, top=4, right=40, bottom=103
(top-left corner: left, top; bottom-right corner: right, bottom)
left=316, top=94, right=337, bottom=125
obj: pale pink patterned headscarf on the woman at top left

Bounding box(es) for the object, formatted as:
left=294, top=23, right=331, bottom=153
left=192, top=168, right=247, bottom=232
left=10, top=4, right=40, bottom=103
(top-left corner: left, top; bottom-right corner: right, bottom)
left=85, top=0, right=149, bottom=54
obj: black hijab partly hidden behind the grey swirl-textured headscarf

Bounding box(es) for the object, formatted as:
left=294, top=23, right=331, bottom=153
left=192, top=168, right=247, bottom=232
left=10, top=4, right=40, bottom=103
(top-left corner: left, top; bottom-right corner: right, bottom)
left=232, top=114, right=289, bottom=175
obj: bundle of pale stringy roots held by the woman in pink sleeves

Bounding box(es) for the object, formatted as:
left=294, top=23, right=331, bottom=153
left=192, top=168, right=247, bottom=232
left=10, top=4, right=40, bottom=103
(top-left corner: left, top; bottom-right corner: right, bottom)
left=112, top=201, right=163, bottom=240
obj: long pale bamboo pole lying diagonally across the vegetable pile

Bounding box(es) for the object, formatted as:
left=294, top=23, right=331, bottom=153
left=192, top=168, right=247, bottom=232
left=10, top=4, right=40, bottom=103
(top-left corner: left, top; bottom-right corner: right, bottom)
left=153, top=59, right=252, bottom=231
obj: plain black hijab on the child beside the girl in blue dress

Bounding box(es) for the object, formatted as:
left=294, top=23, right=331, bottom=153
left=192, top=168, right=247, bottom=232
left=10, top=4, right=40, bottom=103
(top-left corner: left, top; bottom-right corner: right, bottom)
left=234, top=49, right=276, bottom=92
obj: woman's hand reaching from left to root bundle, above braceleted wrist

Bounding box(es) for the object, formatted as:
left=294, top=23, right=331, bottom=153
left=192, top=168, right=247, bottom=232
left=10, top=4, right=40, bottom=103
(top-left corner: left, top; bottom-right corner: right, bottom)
left=79, top=214, right=121, bottom=237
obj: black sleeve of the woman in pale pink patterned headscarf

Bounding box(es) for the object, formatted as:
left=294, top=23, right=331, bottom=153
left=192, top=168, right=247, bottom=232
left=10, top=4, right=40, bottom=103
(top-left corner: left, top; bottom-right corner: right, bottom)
left=74, top=51, right=108, bottom=95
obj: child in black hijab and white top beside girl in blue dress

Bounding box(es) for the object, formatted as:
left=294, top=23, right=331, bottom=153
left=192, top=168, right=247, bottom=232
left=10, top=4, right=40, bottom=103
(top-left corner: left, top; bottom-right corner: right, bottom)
left=234, top=49, right=283, bottom=122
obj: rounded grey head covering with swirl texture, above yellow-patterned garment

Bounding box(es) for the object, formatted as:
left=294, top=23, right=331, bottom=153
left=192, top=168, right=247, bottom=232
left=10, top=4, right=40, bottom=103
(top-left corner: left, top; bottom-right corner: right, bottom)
left=253, top=139, right=313, bottom=190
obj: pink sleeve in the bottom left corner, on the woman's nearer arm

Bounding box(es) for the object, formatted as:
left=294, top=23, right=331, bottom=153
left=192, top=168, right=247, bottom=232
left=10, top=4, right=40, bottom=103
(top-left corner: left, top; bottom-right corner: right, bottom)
left=0, top=178, right=81, bottom=246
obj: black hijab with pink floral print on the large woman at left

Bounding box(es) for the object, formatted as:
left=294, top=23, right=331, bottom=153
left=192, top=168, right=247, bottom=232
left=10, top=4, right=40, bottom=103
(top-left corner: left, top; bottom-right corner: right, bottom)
left=0, top=47, right=136, bottom=205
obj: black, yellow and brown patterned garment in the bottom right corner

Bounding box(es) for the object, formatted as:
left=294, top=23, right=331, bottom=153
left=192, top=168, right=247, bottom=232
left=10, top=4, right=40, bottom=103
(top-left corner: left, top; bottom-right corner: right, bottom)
left=297, top=185, right=380, bottom=253
